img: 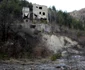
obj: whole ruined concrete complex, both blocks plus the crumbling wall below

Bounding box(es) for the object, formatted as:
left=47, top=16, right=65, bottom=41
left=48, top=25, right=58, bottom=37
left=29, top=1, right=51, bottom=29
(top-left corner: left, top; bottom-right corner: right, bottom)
left=22, top=4, right=51, bottom=33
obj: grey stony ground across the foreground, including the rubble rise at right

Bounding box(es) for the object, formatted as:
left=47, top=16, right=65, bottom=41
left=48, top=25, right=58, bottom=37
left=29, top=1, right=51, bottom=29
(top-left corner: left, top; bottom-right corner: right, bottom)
left=0, top=47, right=85, bottom=70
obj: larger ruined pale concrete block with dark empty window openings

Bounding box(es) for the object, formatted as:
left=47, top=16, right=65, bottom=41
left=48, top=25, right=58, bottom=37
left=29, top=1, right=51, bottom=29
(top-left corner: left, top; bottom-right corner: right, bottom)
left=33, top=4, right=48, bottom=22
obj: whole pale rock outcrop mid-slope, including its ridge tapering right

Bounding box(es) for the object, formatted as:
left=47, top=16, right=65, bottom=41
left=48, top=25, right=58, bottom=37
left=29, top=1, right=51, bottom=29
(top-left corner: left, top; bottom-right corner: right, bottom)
left=42, top=34, right=78, bottom=53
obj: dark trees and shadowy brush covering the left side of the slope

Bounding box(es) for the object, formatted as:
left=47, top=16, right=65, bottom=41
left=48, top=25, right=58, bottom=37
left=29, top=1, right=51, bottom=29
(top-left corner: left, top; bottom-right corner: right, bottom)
left=0, top=0, right=32, bottom=58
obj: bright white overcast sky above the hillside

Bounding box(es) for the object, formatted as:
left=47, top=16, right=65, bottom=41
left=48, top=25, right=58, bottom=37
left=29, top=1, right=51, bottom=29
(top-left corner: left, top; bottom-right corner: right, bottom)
left=27, top=0, right=85, bottom=12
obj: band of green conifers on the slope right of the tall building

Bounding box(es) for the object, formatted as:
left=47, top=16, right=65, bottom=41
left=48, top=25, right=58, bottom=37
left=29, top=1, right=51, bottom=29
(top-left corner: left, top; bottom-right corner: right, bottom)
left=48, top=6, right=85, bottom=30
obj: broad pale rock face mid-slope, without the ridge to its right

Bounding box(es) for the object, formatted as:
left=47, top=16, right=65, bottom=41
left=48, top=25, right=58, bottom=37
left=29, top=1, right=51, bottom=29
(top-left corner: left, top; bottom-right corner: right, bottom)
left=42, top=34, right=64, bottom=53
